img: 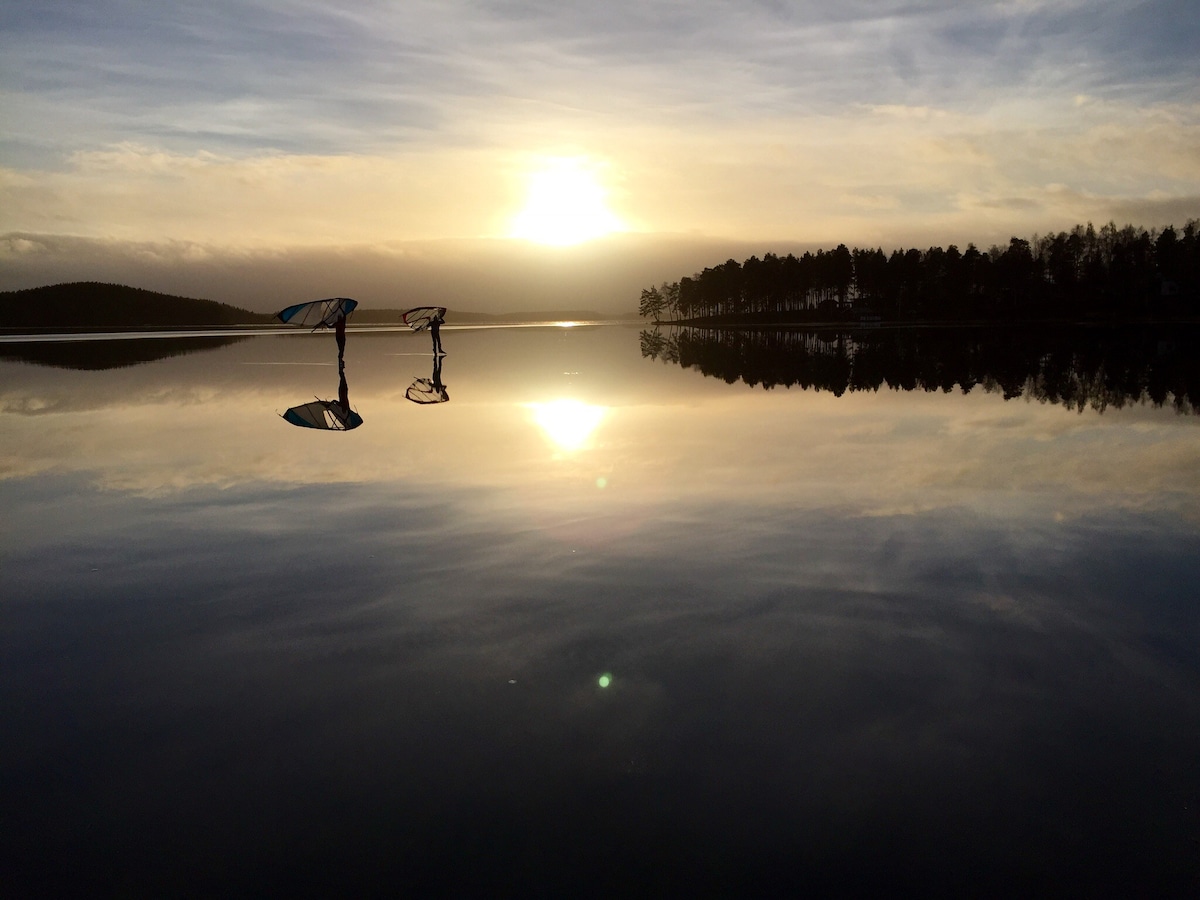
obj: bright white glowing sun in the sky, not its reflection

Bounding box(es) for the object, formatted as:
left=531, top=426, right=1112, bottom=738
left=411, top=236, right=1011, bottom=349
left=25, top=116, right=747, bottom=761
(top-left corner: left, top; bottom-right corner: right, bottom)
left=509, top=158, right=625, bottom=246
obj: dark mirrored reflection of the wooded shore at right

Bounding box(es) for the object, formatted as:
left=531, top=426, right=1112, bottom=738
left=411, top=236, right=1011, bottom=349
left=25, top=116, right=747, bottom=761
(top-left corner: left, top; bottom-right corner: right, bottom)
left=641, top=326, right=1200, bottom=414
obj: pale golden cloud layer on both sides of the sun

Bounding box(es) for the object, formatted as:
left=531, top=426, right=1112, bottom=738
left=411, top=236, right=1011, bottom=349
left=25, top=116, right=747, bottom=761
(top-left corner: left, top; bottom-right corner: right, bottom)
left=7, top=90, right=1200, bottom=254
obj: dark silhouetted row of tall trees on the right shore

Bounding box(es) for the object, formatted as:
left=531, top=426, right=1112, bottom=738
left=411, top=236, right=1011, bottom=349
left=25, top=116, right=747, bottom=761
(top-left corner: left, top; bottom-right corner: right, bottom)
left=638, top=220, right=1200, bottom=323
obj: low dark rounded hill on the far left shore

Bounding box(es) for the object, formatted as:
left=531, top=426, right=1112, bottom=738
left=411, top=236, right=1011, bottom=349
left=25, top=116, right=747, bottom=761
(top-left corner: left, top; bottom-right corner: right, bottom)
left=0, top=281, right=271, bottom=329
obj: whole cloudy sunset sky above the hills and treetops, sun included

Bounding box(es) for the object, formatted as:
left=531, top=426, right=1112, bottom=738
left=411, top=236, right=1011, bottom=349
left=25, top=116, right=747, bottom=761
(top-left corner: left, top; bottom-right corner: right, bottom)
left=0, top=0, right=1200, bottom=312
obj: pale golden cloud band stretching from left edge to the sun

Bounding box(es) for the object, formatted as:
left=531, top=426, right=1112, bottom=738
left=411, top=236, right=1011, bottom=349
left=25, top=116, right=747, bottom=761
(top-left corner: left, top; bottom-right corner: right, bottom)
left=0, top=143, right=520, bottom=247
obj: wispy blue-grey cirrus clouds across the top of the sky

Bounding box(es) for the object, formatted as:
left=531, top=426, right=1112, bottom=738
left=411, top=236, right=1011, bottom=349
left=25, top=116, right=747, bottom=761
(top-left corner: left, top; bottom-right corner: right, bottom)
left=2, top=0, right=1200, bottom=154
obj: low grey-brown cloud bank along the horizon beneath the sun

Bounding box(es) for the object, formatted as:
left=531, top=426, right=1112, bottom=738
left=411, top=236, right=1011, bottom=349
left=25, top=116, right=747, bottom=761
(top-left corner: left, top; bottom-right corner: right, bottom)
left=0, top=233, right=804, bottom=314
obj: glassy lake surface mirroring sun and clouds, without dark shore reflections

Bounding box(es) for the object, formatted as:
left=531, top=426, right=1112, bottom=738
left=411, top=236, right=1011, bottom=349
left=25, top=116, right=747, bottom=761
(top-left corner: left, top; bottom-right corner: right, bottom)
left=0, top=326, right=1200, bottom=896
